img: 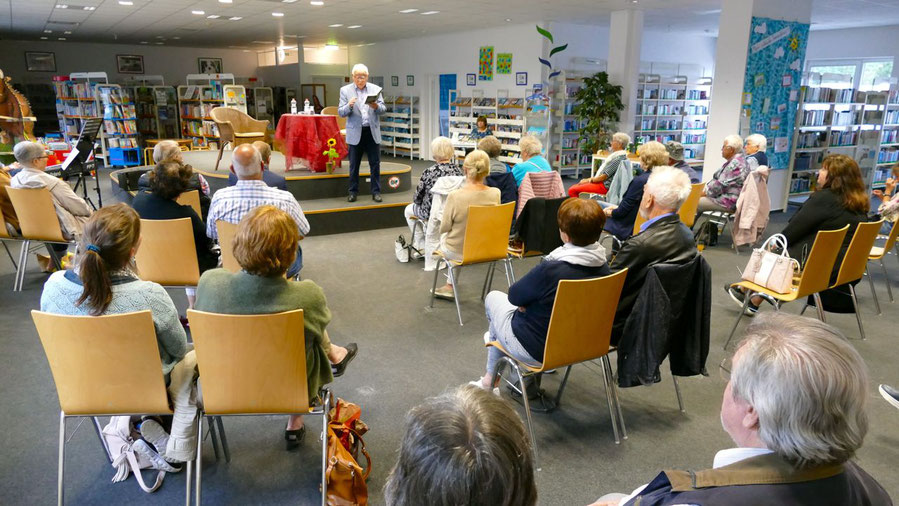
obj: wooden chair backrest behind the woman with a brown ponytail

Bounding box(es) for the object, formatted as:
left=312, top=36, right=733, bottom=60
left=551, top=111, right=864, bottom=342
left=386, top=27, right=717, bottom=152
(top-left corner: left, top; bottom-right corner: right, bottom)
left=31, top=310, right=172, bottom=415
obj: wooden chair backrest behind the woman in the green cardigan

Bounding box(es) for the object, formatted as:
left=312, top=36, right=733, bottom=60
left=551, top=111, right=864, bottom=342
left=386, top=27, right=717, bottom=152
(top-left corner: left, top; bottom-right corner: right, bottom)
left=187, top=309, right=309, bottom=415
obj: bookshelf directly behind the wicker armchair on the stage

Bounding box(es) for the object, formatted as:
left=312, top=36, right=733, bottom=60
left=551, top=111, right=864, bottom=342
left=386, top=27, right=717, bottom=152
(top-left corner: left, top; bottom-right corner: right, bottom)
left=178, top=74, right=234, bottom=149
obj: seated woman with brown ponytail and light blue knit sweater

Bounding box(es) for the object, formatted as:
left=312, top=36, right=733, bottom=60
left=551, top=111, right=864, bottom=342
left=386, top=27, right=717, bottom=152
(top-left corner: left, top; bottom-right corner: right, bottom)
left=41, top=204, right=197, bottom=464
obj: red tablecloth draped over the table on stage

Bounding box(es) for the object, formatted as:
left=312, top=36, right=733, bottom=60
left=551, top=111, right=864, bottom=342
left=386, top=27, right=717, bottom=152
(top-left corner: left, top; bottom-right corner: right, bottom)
left=275, top=114, right=349, bottom=172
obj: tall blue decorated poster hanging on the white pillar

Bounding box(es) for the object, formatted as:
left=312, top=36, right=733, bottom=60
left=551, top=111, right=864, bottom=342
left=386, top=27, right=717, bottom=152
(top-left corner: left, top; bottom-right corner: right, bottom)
left=743, top=17, right=809, bottom=169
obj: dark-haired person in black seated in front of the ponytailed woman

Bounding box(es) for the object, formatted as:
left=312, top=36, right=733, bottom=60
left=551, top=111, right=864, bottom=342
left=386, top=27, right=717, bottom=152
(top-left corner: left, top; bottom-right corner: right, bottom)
left=131, top=162, right=219, bottom=307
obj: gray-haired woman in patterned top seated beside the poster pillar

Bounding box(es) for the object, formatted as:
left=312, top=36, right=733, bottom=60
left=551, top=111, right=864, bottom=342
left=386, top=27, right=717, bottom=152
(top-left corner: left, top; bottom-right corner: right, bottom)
left=693, top=135, right=749, bottom=242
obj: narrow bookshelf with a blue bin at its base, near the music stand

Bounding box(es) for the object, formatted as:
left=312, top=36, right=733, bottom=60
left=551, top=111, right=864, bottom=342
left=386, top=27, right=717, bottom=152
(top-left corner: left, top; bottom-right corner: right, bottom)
left=97, top=84, right=142, bottom=167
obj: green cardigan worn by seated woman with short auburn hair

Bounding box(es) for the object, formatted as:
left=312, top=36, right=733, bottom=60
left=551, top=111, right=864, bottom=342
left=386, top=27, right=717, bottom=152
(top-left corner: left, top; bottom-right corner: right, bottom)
left=194, top=269, right=334, bottom=402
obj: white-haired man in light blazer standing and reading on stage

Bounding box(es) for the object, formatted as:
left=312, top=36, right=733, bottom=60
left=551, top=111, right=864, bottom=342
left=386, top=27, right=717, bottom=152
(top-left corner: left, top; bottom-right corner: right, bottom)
left=337, top=63, right=387, bottom=202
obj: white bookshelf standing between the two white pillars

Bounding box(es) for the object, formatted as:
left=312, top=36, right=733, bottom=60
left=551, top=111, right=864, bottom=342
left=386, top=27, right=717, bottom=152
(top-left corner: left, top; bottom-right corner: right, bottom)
left=634, top=74, right=712, bottom=163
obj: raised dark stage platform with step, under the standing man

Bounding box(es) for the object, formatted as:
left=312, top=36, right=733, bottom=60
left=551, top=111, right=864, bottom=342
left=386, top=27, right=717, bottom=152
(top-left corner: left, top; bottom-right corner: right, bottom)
left=110, top=151, right=413, bottom=235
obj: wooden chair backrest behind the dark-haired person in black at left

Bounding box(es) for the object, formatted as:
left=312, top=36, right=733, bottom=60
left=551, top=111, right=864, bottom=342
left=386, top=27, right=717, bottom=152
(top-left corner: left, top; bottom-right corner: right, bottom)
left=134, top=218, right=200, bottom=286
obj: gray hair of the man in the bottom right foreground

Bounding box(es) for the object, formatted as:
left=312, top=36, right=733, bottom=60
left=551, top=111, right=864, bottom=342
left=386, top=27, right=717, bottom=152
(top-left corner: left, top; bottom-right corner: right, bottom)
left=730, top=313, right=868, bottom=468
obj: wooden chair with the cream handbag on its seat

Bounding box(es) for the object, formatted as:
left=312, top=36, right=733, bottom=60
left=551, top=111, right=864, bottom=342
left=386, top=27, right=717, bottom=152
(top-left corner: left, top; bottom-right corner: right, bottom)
left=724, top=225, right=849, bottom=350
